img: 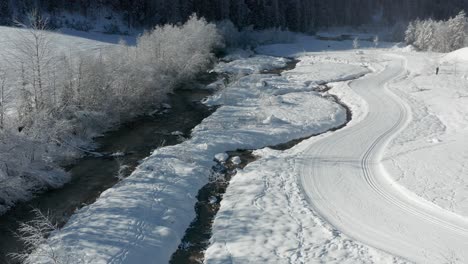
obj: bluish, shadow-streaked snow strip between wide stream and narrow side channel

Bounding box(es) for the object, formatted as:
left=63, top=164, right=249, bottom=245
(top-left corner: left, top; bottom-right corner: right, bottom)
left=32, top=56, right=368, bottom=263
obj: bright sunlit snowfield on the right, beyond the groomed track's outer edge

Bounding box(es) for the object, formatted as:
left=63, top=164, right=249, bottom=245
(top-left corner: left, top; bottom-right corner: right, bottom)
left=385, top=48, right=468, bottom=217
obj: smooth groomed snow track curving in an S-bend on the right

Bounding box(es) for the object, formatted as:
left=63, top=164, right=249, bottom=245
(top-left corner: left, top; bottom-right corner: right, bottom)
left=300, top=54, right=468, bottom=263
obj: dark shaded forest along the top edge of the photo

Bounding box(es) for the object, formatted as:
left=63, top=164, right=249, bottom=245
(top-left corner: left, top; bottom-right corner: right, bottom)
left=0, top=0, right=468, bottom=32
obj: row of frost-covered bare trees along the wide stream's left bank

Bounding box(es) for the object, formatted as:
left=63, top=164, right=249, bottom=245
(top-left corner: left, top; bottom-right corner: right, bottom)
left=0, top=12, right=223, bottom=216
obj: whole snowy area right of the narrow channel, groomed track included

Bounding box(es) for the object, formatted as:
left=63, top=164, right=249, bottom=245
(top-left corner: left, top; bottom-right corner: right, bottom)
left=205, top=39, right=468, bottom=263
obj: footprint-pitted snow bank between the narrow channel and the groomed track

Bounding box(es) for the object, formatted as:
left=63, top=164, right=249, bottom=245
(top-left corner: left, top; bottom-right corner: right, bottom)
left=205, top=80, right=406, bottom=264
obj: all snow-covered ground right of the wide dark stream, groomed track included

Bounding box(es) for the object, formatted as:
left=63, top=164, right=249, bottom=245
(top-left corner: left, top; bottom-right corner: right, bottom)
left=26, top=36, right=468, bottom=263
